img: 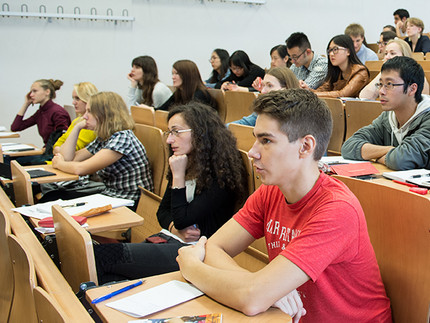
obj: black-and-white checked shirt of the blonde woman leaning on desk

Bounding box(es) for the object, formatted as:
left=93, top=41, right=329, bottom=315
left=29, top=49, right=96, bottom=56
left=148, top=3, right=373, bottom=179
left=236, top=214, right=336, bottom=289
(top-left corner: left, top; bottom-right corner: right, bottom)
left=86, top=130, right=153, bottom=201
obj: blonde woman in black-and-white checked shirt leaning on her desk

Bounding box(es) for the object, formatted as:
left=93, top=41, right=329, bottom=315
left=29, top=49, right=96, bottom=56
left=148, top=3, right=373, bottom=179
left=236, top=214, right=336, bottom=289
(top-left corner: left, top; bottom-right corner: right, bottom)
left=47, top=92, right=153, bottom=209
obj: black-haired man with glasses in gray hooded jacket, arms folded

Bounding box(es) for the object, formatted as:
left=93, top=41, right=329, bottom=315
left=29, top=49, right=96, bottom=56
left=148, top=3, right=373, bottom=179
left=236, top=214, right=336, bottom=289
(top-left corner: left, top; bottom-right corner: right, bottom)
left=342, top=57, right=430, bottom=170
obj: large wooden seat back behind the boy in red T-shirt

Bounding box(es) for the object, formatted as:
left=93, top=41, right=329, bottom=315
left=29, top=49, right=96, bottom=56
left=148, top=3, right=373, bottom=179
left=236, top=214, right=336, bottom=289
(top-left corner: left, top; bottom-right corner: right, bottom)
left=336, top=176, right=430, bottom=322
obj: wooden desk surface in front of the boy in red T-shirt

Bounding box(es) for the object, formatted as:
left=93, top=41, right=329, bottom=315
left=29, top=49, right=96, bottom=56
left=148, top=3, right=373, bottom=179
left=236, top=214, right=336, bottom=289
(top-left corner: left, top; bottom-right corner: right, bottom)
left=86, top=271, right=291, bottom=323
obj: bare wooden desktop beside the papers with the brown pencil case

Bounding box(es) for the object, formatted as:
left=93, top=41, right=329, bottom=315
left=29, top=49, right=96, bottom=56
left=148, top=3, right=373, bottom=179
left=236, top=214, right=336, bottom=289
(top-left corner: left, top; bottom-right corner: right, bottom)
left=30, top=206, right=143, bottom=234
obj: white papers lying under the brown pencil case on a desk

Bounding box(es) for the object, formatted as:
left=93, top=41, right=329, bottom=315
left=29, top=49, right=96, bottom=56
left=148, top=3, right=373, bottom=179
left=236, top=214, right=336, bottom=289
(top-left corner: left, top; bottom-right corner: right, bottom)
left=12, top=194, right=134, bottom=219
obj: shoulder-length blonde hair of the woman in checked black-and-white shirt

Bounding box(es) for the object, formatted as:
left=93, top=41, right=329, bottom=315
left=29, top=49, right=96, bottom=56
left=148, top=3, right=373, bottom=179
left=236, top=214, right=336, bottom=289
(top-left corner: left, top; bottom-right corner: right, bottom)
left=88, top=92, right=134, bottom=140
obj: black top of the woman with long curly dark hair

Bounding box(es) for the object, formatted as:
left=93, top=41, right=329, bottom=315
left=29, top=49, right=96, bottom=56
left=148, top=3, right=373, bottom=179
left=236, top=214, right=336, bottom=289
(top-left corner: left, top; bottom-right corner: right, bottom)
left=157, top=181, right=236, bottom=237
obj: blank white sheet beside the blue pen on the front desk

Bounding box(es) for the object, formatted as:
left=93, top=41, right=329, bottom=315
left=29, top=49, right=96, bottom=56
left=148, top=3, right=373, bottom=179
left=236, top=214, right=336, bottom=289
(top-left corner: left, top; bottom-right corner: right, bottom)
left=106, top=280, right=203, bottom=317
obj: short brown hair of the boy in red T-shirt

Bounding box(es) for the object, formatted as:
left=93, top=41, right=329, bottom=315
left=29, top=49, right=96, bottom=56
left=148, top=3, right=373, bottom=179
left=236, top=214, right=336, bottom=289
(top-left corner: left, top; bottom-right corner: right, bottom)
left=253, top=89, right=333, bottom=160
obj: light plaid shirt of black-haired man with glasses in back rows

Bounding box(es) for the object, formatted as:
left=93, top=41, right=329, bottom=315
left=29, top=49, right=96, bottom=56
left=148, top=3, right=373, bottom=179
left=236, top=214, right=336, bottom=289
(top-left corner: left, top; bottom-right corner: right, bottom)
left=290, top=53, right=328, bottom=90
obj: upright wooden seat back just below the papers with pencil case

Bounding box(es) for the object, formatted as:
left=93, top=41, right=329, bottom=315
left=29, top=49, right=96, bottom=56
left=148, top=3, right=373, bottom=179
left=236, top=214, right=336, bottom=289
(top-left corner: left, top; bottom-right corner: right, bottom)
left=52, top=205, right=98, bottom=293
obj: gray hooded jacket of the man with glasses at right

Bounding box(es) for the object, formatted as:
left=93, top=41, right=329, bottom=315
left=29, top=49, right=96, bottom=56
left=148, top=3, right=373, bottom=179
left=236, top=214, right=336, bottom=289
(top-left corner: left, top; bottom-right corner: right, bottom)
left=342, top=95, right=430, bottom=170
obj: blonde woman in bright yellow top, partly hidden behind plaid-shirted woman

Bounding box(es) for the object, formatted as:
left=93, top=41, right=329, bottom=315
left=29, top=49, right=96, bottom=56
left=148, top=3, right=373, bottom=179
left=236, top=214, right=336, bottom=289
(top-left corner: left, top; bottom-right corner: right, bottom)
left=54, top=82, right=98, bottom=154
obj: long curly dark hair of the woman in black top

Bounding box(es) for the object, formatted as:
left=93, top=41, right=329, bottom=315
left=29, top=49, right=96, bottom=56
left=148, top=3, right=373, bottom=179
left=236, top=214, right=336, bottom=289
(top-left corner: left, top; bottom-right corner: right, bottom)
left=167, top=101, right=246, bottom=199
